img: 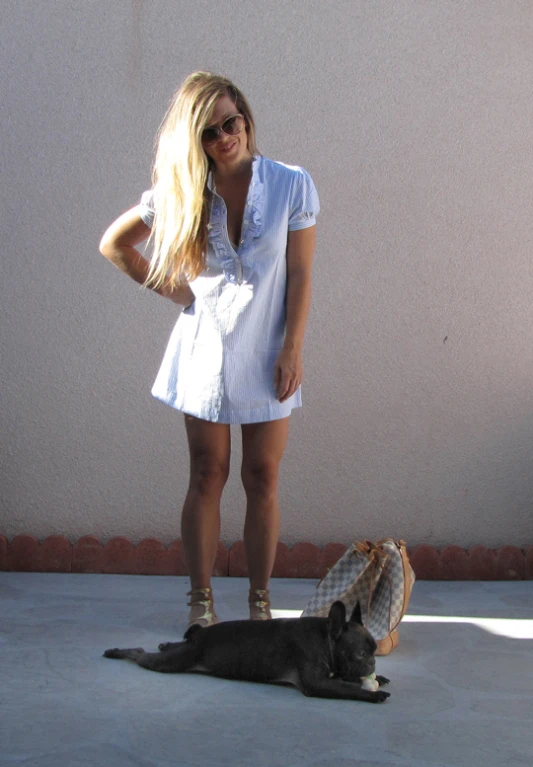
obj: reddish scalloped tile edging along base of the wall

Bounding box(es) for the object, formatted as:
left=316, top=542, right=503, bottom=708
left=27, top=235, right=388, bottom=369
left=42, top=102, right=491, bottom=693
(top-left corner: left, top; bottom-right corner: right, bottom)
left=0, top=535, right=533, bottom=580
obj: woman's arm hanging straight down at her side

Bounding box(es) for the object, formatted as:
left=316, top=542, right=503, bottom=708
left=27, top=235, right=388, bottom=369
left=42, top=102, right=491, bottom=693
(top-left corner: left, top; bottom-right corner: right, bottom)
left=274, top=226, right=316, bottom=402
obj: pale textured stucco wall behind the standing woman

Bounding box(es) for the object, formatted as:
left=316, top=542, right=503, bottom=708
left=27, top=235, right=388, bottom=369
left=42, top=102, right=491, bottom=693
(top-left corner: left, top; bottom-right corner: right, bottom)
left=0, top=0, right=533, bottom=546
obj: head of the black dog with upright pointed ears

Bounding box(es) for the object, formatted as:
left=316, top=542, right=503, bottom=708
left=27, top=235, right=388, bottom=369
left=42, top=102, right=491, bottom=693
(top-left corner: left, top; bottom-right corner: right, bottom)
left=328, top=602, right=377, bottom=682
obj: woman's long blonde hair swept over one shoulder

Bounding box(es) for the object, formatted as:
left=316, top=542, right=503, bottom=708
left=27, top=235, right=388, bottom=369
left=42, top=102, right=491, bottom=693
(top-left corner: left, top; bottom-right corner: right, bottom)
left=146, top=72, right=256, bottom=287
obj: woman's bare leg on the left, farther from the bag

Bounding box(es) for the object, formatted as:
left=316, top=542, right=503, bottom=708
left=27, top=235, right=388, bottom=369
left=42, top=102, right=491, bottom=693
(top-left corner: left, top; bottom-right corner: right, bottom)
left=181, top=415, right=231, bottom=591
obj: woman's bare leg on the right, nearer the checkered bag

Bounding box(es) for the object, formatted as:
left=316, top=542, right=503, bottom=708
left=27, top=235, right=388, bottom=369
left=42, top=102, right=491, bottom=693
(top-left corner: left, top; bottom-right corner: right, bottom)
left=241, top=418, right=289, bottom=589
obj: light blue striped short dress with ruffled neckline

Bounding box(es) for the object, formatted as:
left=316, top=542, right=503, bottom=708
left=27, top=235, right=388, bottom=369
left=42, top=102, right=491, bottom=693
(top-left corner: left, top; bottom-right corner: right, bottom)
left=141, top=155, right=319, bottom=424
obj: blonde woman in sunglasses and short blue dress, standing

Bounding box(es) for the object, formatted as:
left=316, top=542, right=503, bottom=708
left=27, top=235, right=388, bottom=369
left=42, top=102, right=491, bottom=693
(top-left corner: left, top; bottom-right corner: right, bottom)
left=100, top=72, right=319, bottom=626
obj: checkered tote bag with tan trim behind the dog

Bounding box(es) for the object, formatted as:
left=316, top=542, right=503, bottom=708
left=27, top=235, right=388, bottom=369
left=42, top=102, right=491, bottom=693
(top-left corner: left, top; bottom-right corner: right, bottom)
left=302, top=538, right=415, bottom=655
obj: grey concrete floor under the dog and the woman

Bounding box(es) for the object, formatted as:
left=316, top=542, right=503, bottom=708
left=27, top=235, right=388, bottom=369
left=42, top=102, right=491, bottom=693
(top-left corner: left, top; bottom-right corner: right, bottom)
left=0, top=573, right=533, bottom=767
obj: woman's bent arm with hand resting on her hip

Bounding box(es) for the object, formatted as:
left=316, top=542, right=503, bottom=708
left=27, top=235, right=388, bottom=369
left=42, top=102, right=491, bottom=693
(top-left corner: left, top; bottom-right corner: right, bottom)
left=100, top=205, right=194, bottom=306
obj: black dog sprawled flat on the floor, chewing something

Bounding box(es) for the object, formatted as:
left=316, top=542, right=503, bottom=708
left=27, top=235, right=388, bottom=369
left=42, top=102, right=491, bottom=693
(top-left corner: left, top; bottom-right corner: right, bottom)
left=104, top=602, right=389, bottom=703
